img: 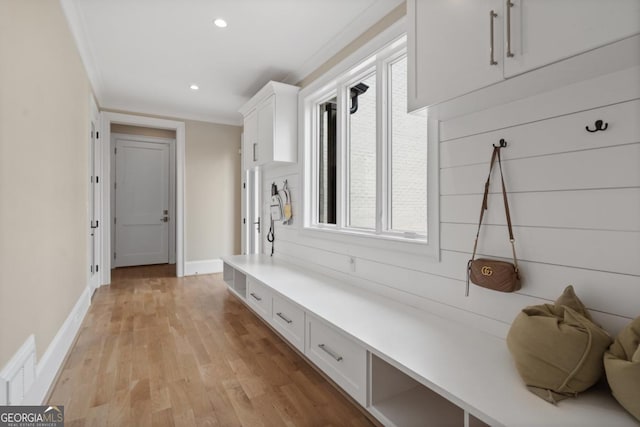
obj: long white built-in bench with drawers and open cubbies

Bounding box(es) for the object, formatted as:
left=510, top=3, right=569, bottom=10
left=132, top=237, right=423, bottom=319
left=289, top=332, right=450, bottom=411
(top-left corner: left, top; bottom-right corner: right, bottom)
left=223, top=255, right=638, bottom=427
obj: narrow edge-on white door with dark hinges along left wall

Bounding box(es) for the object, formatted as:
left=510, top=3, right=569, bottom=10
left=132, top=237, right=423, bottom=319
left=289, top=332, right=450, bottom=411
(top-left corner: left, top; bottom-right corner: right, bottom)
left=89, top=113, right=102, bottom=290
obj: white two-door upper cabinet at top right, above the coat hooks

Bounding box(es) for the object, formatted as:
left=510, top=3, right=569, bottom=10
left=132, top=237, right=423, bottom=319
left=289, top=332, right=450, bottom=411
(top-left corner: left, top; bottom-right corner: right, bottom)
left=407, top=0, right=640, bottom=111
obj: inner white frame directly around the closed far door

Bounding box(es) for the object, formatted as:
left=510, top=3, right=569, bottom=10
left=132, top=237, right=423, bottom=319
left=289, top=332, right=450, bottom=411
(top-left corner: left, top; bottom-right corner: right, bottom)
left=109, top=132, right=176, bottom=265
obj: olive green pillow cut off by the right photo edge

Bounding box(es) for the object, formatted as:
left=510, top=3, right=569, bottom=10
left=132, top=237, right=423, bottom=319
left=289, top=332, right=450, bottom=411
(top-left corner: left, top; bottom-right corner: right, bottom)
left=604, top=317, right=640, bottom=421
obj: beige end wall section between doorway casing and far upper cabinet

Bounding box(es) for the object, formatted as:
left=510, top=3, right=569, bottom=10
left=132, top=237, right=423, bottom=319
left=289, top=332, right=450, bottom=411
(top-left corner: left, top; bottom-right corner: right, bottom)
left=185, top=121, right=242, bottom=261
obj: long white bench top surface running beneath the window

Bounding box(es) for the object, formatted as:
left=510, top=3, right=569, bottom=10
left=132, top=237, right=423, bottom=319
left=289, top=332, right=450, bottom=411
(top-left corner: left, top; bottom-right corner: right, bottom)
left=223, top=255, right=640, bottom=427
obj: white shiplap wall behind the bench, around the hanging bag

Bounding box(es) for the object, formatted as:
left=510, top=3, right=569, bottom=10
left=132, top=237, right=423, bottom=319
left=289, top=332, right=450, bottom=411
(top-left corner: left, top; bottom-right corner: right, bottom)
left=263, top=67, right=640, bottom=342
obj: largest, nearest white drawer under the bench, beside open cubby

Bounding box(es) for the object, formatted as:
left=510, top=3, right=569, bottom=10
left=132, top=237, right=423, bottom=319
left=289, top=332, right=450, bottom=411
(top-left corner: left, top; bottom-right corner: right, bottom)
left=305, top=314, right=367, bottom=406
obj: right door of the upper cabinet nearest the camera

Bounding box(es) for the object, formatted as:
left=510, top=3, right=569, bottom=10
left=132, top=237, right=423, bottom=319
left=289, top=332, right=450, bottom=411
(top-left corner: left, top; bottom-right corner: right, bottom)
left=504, top=0, right=640, bottom=77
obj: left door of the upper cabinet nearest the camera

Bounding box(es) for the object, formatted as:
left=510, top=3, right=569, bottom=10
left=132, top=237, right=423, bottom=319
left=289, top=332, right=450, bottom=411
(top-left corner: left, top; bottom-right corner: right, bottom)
left=407, top=0, right=504, bottom=111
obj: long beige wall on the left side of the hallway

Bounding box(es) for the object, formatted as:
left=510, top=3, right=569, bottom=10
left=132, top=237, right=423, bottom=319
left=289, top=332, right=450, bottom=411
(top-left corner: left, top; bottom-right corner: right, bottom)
left=0, top=0, right=91, bottom=368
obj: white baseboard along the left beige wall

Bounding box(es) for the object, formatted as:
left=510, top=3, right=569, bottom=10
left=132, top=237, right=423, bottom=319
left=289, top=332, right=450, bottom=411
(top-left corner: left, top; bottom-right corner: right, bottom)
left=22, top=286, right=91, bottom=405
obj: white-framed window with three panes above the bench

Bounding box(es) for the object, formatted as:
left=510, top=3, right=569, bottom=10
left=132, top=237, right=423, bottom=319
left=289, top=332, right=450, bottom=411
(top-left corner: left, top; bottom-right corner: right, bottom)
left=301, top=38, right=437, bottom=254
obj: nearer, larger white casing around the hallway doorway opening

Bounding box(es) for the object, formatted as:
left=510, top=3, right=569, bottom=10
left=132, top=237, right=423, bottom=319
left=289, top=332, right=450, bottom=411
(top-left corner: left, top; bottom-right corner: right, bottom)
left=102, top=111, right=186, bottom=284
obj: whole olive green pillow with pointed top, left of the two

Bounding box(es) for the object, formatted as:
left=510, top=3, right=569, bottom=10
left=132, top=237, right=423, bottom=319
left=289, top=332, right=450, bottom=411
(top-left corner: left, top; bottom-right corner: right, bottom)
left=507, top=286, right=611, bottom=403
